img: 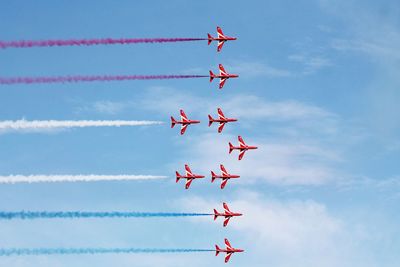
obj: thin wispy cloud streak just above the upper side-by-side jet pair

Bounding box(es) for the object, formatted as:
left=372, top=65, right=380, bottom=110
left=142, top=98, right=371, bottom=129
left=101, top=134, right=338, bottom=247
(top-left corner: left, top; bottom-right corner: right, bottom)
left=142, top=87, right=337, bottom=124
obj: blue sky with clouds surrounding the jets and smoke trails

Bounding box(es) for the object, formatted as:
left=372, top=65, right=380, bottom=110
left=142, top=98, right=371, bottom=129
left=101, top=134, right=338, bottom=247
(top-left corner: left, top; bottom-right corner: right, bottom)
left=0, top=0, right=400, bottom=267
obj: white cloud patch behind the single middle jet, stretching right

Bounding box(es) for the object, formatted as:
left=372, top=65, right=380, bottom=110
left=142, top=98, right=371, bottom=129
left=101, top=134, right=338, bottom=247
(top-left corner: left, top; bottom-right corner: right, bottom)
left=177, top=134, right=340, bottom=186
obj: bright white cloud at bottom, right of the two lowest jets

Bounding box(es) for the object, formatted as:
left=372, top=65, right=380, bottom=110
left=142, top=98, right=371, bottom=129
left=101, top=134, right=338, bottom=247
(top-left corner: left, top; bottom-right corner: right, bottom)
left=176, top=191, right=384, bottom=267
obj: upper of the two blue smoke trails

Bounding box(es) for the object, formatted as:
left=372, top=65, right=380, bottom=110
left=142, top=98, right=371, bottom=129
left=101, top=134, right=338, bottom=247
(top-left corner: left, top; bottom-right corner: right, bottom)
left=0, top=211, right=213, bottom=220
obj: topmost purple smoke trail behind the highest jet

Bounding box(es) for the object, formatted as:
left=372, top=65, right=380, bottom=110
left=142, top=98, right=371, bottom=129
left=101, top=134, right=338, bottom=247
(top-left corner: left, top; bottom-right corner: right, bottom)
left=0, top=38, right=207, bottom=49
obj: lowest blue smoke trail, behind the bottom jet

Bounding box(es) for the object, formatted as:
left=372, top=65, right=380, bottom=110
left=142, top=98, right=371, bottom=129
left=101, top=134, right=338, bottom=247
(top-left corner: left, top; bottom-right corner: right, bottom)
left=0, top=248, right=215, bottom=256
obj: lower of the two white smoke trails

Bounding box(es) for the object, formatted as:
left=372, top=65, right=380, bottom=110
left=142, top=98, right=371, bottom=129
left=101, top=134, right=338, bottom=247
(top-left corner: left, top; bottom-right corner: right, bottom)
left=0, top=174, right=167, bottom=184
